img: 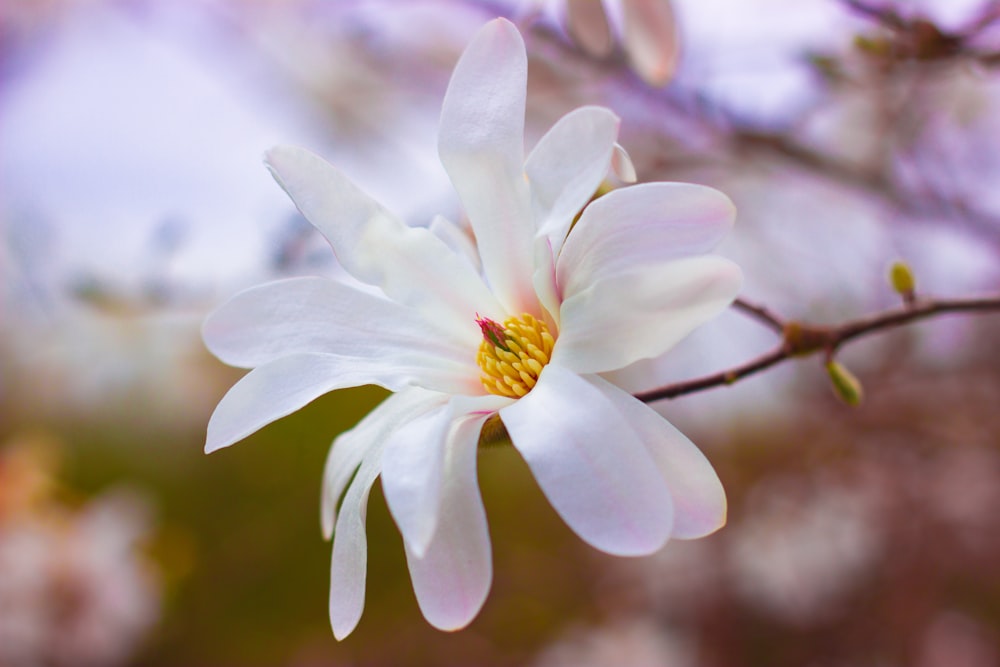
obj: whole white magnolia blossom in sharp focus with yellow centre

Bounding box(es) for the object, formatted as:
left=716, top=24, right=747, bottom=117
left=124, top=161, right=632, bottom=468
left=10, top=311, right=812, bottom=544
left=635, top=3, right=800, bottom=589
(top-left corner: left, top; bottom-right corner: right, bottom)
left=204, top=19, right=741, bottom=638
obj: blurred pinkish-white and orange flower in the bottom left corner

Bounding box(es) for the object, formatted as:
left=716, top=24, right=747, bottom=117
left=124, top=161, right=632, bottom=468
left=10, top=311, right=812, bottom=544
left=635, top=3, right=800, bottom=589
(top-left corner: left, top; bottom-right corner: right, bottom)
left=0, top=447, right=159, bottom=667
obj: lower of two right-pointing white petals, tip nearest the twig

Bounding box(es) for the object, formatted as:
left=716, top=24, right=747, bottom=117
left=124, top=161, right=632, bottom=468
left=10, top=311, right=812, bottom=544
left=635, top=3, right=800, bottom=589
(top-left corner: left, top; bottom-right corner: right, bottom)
left=552, top=255, right=743, bottom=373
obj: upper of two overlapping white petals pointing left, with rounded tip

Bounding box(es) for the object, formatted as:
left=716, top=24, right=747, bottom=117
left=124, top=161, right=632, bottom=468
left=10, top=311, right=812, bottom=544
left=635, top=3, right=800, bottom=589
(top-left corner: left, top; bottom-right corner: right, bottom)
left=202, top=277, right=480, bottom=370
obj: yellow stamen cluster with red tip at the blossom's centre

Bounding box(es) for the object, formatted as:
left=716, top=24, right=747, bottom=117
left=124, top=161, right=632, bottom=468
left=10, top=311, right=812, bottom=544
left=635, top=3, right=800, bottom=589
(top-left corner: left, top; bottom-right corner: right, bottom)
left=476, top=313, right=556, bottom=398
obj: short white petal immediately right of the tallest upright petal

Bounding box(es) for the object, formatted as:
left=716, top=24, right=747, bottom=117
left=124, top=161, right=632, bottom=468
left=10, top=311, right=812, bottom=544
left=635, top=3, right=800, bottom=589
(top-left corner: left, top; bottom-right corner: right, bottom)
left=524, top=107, right=619, bottom=255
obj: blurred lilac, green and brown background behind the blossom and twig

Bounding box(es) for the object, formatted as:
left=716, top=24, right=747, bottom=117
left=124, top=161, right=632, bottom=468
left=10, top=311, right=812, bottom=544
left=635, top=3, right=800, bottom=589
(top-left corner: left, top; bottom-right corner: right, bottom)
left=0, top=0, right=1000, bottom=667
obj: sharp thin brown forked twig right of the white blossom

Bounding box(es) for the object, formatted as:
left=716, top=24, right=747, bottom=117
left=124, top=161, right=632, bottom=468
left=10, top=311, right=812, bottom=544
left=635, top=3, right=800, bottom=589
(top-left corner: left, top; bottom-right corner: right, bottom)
left=635, top=296, right=1000, bottom=403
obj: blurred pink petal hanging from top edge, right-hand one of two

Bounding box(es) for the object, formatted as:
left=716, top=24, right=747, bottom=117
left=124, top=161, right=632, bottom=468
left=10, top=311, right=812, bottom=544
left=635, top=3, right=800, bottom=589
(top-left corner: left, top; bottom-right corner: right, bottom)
left=621, top=0, right=680, bottom=86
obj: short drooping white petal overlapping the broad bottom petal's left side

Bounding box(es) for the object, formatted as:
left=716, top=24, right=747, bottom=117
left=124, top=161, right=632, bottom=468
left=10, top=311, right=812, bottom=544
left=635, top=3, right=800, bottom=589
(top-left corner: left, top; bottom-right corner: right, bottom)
left=382, top=394, right=511, bottom=558
